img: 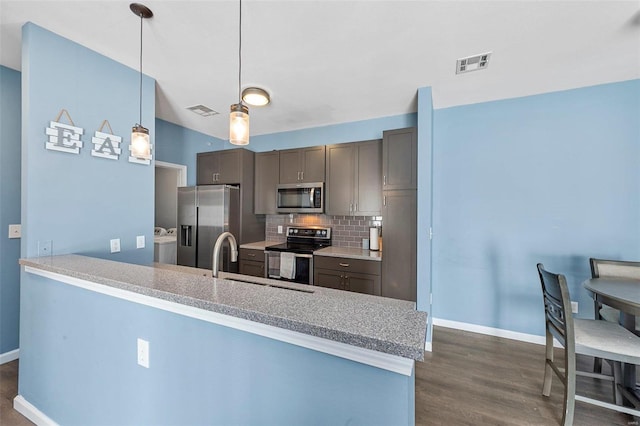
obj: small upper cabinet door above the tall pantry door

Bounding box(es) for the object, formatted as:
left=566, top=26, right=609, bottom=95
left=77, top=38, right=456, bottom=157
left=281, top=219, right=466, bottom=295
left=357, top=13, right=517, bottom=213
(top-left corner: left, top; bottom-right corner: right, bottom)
left=382, top=127, right=418, bottom=190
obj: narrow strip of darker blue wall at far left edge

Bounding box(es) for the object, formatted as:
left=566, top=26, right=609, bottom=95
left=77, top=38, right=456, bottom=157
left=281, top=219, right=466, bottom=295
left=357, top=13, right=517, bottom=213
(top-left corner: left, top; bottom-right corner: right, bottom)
left=0, top=66, right=21, bottom=355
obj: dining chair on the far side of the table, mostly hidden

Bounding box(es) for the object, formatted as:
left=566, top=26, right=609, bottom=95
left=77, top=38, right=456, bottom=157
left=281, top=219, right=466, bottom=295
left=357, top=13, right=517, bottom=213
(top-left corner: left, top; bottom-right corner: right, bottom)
left=589, top=257, right=640, bottom=373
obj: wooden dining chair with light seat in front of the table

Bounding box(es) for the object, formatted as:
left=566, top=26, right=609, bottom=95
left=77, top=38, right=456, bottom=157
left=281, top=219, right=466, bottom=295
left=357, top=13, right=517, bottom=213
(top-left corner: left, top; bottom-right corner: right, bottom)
left=537, top=263, right=640, bottom=426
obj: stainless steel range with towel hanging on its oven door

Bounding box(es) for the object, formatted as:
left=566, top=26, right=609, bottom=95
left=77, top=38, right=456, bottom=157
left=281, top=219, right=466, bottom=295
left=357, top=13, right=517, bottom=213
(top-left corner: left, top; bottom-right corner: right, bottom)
left=265, top=226, right=331, bottom=285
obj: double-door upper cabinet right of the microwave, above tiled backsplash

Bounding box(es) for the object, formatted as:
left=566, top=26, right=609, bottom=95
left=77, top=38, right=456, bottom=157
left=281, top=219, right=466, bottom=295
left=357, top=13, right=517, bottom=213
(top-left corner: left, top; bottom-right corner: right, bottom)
left=325, top=140, right=382, bottom=216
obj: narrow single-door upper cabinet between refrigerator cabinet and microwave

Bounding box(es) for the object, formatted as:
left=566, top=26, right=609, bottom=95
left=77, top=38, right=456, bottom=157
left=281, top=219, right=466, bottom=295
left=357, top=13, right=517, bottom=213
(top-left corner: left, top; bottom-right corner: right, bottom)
left=254, top=151, right=280, bottom=214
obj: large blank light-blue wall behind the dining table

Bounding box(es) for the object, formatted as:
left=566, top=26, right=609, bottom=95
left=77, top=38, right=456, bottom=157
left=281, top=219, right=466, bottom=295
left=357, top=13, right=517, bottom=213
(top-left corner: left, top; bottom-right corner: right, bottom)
left=433, top=80, right=640, bottom=335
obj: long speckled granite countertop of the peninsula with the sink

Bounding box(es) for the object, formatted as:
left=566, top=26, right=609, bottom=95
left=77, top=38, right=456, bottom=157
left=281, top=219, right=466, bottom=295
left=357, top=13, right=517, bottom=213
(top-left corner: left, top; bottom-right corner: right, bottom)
left=20, top=255, right=427, bottom=360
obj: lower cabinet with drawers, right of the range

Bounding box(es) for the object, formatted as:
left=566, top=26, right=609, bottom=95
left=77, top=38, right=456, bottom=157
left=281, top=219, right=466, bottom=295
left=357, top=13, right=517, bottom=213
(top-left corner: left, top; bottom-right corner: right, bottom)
left=313, top=256, right=380, bottom=296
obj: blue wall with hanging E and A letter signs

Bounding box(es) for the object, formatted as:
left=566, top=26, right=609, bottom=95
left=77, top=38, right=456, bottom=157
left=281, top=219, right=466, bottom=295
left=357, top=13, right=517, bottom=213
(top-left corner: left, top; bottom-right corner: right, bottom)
left=21, top=23, right=155, bottom=263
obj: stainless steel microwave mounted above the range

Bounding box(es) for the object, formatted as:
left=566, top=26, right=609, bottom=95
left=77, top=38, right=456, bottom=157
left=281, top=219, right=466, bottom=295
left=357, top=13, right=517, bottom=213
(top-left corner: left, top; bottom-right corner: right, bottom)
left=276, top=182, right=324, bottom=213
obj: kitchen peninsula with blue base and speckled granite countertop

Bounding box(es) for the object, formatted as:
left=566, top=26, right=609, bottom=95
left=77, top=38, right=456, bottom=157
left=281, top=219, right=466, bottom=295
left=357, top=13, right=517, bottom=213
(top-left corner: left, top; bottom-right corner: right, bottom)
left=15, top=255, right=426, bottom=425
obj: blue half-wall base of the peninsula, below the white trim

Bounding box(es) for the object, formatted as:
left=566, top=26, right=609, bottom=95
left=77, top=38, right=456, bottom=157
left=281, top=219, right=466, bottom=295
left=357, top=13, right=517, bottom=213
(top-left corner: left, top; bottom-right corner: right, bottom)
left=19, top=275, right=415, bottom=426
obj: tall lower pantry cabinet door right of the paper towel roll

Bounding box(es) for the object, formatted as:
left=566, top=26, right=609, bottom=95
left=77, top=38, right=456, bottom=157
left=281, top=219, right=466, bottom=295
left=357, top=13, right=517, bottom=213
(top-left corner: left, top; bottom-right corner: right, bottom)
left=382, top=189, right=417, bottom=302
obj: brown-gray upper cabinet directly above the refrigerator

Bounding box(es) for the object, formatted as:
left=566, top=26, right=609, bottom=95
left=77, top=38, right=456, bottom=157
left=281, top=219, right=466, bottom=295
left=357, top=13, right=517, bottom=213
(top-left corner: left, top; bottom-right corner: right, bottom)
left=196, top=148, right=245, bottom=185
